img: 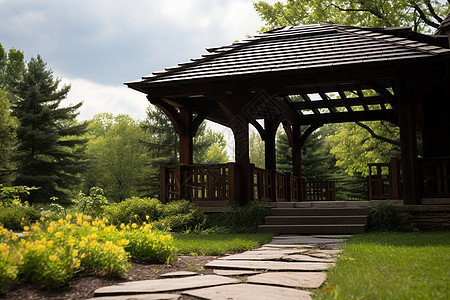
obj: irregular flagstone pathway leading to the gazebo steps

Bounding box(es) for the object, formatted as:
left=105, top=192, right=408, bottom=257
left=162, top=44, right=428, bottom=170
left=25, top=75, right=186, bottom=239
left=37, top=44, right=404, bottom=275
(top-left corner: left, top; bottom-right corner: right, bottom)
left=92, top=235, right=348, bottom=300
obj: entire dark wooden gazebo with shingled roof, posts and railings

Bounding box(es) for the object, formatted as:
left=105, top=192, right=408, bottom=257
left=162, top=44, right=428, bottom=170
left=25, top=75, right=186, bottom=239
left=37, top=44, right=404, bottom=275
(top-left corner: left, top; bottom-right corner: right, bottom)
left=126, top=23, right=450, bottom=214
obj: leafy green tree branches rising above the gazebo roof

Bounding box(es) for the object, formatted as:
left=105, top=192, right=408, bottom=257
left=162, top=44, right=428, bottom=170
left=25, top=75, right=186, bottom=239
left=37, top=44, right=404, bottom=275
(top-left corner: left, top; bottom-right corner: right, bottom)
left=253, top=0, right=450, bottom=31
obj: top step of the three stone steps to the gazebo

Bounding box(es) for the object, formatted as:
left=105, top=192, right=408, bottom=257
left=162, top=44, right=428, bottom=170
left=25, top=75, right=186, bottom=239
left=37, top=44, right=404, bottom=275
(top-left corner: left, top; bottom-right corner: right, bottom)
left=271, top=207, right=368, bottom=216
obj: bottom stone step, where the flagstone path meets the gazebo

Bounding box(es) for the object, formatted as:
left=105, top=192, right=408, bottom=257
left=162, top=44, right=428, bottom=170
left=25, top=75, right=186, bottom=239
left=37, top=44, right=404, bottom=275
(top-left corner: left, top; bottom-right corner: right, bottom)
left=258, top=224, right=366, bottom=234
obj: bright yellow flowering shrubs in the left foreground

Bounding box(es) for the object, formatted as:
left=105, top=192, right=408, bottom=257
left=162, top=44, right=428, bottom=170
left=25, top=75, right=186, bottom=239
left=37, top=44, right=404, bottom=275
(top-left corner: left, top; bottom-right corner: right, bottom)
left=0, top=214, right=173, bottom=288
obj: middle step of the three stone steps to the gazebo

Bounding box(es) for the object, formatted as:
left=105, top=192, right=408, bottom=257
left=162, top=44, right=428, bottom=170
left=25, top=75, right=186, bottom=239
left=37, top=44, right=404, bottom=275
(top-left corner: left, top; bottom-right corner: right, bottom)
left=265, top=215, right=368, bottom=225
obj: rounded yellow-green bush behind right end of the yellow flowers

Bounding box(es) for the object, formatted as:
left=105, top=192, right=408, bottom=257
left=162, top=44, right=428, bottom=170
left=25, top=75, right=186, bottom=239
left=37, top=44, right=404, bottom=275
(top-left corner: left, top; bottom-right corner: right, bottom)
left=104, top=197, right=161, bottom=225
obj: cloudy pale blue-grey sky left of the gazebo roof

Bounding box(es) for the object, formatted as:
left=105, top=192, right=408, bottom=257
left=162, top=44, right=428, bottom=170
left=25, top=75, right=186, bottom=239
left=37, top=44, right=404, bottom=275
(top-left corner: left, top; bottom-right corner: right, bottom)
left=0, top=0, right=275, bottom=120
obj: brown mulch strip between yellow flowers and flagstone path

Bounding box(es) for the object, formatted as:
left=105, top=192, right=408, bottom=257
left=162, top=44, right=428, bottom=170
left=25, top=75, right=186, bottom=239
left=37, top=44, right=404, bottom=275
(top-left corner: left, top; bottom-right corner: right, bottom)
left=0, top=256, right=216, bottom=300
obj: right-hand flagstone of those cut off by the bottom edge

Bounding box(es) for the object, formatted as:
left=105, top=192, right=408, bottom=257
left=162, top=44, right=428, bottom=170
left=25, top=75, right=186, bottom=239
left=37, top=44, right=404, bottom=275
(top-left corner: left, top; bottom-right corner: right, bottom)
left=182, top=283, right=311, bottom=300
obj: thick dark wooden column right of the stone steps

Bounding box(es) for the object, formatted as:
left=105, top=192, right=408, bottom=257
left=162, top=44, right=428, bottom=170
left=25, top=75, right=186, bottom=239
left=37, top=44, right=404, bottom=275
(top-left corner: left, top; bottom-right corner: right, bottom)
left=399, top=81, right=420, bottom=205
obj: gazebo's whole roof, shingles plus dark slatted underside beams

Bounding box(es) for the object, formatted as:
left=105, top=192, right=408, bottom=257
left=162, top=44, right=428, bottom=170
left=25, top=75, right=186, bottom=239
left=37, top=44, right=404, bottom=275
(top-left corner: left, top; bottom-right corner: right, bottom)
left=126, top=23, right=450, bottom=125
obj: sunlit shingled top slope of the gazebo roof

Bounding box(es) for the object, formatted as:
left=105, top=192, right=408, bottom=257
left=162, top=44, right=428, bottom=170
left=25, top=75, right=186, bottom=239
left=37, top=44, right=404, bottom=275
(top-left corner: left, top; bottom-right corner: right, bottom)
left=127, top=23, right=450, bottom=88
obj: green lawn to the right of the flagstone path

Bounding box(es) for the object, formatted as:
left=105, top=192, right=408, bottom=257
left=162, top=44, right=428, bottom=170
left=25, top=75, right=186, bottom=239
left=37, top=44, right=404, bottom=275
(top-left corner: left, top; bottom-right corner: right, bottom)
left=314, top=232, right=450, bottom=299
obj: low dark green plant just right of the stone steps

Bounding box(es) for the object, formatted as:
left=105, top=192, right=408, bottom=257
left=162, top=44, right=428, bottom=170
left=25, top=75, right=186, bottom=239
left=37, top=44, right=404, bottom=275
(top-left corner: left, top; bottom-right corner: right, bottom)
left=369, top=203, right=414, bottom=231
